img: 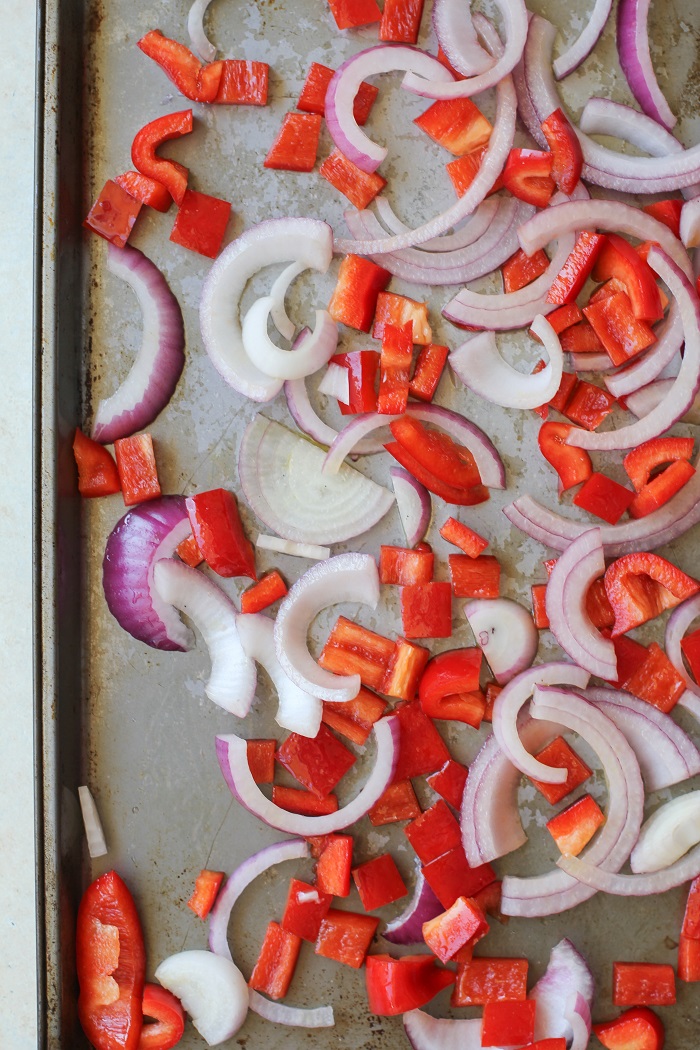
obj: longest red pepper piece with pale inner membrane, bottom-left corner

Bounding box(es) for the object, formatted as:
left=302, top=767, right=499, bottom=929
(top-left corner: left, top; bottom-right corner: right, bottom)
left=76, top=872, right=146, bottom=1050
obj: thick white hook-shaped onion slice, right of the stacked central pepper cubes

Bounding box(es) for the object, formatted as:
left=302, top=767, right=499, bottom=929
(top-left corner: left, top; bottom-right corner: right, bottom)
left=448, top=314, right=564, bottom=410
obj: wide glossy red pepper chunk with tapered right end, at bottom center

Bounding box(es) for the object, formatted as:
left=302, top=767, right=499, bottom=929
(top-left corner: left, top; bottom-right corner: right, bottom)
left=365, top=956, right=454, bottom=1017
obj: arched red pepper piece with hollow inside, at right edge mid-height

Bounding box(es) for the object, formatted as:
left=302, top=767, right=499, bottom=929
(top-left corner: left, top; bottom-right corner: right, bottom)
left=606, top=551, right=700, bottom=637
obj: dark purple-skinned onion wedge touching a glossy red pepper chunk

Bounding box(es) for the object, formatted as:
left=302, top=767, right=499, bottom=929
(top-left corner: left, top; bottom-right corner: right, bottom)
left=102, top=496, right=194, bottom=652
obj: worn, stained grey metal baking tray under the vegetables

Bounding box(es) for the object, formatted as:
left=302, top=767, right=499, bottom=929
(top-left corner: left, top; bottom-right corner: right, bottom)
left=37, top=0, right=700, bottom=1050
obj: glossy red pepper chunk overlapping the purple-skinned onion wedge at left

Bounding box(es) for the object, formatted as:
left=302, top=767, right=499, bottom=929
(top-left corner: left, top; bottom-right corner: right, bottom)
left=186, top=488, right=257, bottom=580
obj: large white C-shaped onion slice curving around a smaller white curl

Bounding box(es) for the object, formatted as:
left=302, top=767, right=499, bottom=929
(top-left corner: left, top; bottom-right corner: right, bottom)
left=199, top=218, right=333, bottom=401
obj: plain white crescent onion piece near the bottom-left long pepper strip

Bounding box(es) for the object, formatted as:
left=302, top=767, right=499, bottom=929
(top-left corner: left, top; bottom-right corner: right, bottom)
left=155, top=949, right=248, bottom=1047
